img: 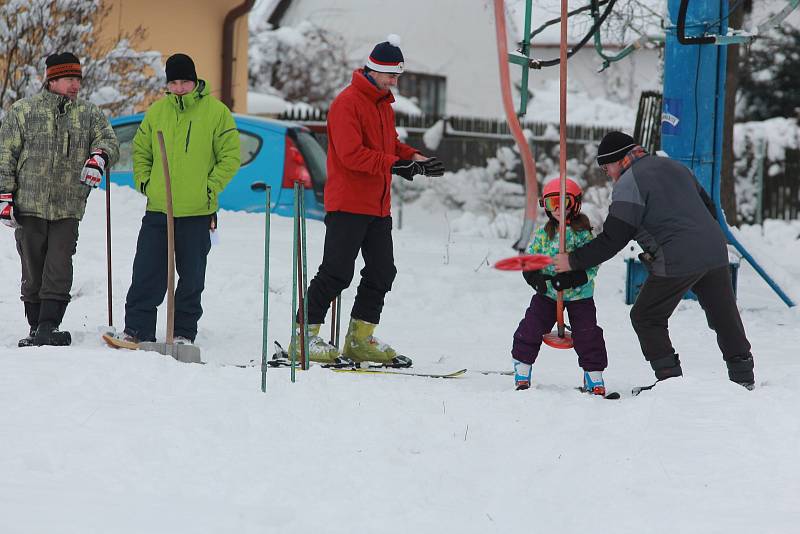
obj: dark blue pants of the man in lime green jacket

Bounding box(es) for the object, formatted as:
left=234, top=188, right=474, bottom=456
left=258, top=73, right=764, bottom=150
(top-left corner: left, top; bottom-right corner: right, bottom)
left=125, top=211, right=211, bottom=341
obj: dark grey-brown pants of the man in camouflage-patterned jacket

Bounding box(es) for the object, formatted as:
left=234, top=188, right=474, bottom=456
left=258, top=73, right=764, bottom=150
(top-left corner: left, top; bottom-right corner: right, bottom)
left=14, top=215, right=79, bottom=328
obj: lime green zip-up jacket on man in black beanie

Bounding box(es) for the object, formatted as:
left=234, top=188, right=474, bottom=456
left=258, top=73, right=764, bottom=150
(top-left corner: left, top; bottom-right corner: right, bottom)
left=133, top=80, right=241, bottom=217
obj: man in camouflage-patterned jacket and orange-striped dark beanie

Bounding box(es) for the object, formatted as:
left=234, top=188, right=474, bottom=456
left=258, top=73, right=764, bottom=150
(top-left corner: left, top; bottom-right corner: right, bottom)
left=0, top=52, right=119, bottom=346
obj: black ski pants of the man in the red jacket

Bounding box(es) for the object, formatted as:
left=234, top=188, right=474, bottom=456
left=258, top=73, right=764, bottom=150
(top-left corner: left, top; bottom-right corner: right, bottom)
left=308, top=211, right=397, bottom=324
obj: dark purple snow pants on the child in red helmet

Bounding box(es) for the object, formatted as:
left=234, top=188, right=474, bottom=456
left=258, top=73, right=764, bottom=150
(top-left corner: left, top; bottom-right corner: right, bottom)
left=511, top=293, right=608, bottom=371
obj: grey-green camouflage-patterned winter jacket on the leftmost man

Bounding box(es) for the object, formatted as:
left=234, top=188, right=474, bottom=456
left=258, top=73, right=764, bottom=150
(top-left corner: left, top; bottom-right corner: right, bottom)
left=0, top=90, right=119, bottom=221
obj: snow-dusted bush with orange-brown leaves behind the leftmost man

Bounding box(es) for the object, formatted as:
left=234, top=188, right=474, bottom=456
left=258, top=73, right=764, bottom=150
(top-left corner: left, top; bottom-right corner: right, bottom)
left=0, top=0, right=164, bottom=118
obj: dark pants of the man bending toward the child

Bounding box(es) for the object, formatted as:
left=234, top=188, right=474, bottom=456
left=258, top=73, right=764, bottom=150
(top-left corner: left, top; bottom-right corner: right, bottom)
left=631, top=265, right=753, bottom=382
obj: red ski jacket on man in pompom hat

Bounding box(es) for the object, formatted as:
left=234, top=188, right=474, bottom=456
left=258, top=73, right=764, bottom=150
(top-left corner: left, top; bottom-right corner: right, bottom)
left=325, top=69, right=417, bottom=217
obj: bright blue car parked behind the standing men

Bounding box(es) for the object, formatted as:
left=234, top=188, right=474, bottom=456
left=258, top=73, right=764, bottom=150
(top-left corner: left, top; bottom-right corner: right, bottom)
left=111, top=113, right=327, bottom=220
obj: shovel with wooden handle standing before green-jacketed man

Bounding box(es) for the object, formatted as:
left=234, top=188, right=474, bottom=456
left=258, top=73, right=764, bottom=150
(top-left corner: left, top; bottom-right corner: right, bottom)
left=139, top=130, right=202, bottom=363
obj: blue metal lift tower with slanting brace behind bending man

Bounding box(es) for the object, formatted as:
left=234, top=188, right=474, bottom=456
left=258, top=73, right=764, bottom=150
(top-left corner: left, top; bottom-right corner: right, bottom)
left=661, top=0, right=795, bottom=306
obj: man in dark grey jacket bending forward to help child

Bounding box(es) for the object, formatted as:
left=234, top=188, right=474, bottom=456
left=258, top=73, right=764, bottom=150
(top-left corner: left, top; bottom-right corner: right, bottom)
left=556, top=132, right=755, bottom=389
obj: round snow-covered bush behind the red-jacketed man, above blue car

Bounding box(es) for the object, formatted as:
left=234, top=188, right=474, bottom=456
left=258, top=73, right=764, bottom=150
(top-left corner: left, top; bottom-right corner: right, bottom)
left=248, top=19, right=351, bottom=109
